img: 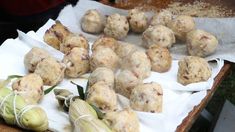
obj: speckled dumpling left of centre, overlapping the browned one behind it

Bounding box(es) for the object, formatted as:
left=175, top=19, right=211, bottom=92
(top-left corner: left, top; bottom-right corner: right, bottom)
left=62, top=47, right=90, bottom=78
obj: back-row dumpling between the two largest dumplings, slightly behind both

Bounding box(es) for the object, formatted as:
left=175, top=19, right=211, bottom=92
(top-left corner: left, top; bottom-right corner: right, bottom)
left=168, top=15, right=195, bottom=41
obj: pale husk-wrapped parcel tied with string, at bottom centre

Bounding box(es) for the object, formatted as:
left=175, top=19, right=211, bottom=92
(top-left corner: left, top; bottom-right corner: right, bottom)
left=69, top=99, right=111, bottom=132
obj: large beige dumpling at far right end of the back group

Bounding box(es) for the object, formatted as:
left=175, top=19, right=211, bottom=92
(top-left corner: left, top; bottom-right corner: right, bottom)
left=186, top=30, right=218, bottom=57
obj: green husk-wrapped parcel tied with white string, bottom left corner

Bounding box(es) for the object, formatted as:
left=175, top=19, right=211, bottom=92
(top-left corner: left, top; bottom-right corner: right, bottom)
left=0, top=87, right=48, bottom=131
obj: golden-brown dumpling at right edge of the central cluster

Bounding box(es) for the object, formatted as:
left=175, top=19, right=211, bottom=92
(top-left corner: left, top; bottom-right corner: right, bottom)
left=146, top=45, right=172, bottom=73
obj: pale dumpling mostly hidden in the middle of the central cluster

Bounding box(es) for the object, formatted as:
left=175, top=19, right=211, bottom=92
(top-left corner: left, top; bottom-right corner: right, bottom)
left=116, top=42, right=137, bottom=60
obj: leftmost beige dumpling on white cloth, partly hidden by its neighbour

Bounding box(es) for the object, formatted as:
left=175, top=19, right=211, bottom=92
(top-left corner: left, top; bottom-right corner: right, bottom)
left=24, top=47, right=51, bottom=72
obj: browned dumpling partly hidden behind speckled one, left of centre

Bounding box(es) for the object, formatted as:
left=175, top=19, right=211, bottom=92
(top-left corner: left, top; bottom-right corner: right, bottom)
left=60, top=34, right=89, bottom=54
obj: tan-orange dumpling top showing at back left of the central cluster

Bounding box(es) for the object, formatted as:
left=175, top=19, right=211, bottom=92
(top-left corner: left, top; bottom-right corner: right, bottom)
left=92, top=37, right=118, bottom=51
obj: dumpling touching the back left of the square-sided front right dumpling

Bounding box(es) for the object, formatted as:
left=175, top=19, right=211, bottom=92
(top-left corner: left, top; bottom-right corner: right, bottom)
left=115, top=70, right=142, bottom=98
